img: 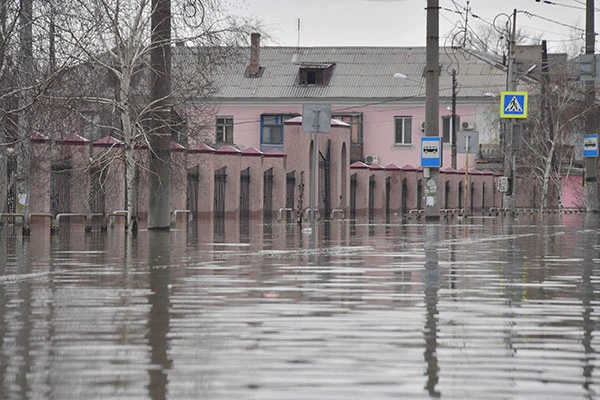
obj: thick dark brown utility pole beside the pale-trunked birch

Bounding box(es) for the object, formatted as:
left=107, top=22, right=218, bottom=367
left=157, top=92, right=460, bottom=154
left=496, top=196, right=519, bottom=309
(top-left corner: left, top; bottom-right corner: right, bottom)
left=148, top=0, right=171, bottom=230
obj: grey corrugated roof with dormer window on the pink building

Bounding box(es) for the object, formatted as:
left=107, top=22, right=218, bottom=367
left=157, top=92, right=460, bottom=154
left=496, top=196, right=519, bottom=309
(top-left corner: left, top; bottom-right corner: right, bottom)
left=209, top=47, right=506, bottom=101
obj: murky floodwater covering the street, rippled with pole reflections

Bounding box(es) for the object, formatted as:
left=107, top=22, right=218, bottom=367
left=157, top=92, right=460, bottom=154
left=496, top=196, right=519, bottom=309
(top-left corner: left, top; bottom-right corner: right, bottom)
left=0, top=215, right=600, bottom=400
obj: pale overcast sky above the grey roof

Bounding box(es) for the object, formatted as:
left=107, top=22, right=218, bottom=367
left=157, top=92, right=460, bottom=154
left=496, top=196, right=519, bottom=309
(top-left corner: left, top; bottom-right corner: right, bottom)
left=230, top=0, right=600, bottom=51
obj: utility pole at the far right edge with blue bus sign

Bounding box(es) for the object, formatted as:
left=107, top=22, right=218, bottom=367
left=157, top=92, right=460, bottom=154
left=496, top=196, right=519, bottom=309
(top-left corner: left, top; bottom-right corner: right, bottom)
left=584, top=0, right=598, bottom=212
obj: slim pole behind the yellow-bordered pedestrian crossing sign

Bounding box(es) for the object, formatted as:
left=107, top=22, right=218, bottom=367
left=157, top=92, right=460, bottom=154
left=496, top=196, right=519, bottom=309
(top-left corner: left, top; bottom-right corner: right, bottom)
left=503, top=9, right=517, bottom=216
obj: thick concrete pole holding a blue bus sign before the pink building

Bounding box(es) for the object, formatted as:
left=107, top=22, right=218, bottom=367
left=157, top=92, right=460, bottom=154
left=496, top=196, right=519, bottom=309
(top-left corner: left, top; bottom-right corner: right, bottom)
left=423, top=0, right=443, bottom=219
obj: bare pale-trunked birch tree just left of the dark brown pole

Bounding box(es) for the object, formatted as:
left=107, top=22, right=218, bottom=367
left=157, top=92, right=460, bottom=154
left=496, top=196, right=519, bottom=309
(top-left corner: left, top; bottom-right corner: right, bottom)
left=47, top=0, right=260, bottom=229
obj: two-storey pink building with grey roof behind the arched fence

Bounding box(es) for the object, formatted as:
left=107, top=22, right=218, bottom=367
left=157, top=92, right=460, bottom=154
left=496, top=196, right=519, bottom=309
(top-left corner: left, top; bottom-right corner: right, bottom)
left=204, top=35, right=506, bottom=170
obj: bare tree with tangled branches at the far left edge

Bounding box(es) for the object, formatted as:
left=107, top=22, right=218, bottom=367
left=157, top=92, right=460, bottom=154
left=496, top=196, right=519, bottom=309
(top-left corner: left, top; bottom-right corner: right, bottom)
left=0, top=0, right=78, bottom=234
